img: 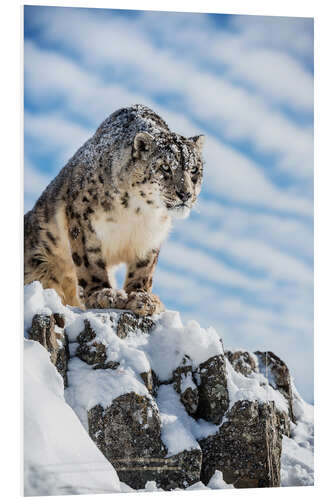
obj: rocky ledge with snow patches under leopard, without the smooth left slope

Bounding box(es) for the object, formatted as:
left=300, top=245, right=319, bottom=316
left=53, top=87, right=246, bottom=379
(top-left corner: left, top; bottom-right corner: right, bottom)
left=26, top=290, right=297, bottom=490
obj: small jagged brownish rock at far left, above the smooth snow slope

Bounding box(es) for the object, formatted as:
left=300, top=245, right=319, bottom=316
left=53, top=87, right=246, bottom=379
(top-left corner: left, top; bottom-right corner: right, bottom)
left=29, top=314, right=69, bottom=387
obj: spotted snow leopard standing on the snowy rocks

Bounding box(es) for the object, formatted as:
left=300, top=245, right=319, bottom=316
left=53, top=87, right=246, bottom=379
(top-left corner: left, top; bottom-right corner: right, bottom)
left=24, top=104, right=204, bottom=316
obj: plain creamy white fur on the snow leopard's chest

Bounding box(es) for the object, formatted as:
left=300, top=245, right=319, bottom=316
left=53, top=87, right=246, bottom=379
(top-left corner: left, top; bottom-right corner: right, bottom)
left=92, top=202, right=171, bottom=266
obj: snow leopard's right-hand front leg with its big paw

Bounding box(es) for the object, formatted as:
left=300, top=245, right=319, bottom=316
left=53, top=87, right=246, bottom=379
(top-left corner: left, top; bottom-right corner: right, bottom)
left=124, top=249, right=165, bottom=316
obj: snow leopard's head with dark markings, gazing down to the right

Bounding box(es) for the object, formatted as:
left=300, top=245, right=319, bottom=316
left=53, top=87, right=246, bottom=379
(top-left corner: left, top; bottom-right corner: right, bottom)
left=133, top=132, right=204, bottom=218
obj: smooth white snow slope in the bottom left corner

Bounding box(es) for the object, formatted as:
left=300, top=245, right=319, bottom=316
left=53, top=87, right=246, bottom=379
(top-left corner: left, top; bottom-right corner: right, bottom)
left=24, top=340, right=121, bottom=496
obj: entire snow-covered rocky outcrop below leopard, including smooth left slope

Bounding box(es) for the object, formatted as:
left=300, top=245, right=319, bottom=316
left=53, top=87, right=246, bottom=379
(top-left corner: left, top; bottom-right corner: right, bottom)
left=25, top=282, right=313, bottom=495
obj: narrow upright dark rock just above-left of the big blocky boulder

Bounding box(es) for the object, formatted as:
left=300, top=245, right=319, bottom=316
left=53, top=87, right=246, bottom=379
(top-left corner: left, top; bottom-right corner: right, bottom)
left=194, top=354, right=229, bottom=424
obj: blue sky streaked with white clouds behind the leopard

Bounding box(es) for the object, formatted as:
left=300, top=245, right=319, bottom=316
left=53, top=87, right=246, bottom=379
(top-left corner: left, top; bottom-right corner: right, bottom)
left=24, top=6, right=313, bottom=402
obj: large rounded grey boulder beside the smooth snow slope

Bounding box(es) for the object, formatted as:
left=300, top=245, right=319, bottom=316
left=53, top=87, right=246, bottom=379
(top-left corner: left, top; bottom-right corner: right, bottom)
left=88, top=392, right=167, bottom=489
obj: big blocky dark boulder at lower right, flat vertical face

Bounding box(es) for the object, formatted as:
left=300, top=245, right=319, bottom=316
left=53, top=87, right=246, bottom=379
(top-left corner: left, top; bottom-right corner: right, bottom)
left=199, top=401, right=282, bottom=488
